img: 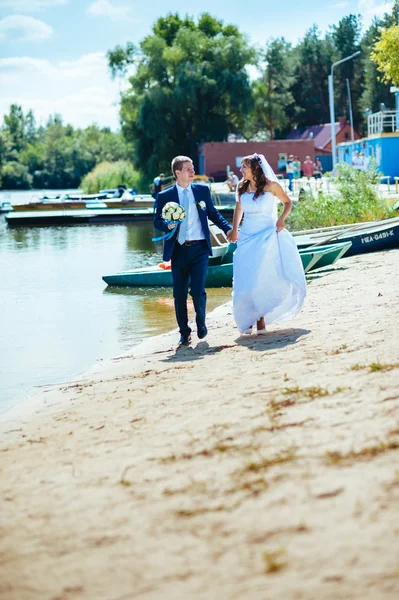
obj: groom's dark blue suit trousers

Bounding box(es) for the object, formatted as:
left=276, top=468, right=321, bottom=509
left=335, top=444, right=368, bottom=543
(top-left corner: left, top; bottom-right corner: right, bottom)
left=172, top=240, right=209, bottom=335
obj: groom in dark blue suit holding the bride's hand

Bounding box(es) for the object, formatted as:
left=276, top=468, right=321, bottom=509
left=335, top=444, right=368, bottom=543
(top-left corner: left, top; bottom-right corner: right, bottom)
left=154, top=156, right=232, bottom=346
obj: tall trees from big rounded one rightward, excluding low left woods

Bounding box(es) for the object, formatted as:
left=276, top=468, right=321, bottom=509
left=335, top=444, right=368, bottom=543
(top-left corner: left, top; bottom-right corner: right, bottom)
left=108, top=0, right=399, bottom=174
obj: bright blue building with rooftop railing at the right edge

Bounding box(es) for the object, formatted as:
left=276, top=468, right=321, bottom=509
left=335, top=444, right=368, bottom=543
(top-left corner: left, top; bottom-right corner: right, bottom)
left=337, top=110, right=399, bottom=182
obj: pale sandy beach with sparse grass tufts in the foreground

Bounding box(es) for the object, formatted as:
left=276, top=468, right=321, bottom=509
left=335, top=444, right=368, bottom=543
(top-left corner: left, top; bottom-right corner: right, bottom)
left=0, top=250, right=399, bottom=600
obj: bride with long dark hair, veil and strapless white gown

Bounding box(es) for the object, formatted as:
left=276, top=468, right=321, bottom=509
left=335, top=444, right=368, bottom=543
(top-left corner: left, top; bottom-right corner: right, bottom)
left=230, top=154, right=306, bottom=333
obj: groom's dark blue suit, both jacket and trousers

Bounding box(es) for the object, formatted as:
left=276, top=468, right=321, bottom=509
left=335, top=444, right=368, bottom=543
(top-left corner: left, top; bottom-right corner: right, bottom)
left=154, top=184, right=231, bottom=336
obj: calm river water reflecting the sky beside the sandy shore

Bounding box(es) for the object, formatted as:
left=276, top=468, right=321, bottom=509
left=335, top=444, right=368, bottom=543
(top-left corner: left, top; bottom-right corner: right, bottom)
left=0, top=192, right=231, bottom=412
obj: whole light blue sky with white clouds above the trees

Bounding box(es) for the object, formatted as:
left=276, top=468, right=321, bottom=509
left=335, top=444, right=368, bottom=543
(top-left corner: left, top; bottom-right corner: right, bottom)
left=0, top=0, right=391, bottom=130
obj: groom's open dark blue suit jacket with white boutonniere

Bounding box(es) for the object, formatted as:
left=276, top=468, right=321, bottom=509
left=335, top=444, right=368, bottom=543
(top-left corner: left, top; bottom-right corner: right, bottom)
left=154, top=183, right=231, bottom=260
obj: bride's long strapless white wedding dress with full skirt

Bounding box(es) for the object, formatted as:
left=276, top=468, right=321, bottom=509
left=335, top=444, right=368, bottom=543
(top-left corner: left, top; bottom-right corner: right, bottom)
left=233, top=192, right=306, bottom=332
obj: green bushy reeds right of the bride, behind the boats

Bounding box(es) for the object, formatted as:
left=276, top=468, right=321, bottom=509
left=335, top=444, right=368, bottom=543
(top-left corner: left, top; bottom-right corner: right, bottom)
left=287, top=163, right=391, bottom=231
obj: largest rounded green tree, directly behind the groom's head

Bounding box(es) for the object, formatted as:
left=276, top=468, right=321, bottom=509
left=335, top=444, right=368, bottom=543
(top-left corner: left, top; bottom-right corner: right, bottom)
left=108, top=13, right=255, bottom=175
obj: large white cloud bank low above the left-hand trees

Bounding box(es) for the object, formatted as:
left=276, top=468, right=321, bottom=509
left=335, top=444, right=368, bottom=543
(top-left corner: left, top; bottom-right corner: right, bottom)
left=0, top=52, right=119, bottom=129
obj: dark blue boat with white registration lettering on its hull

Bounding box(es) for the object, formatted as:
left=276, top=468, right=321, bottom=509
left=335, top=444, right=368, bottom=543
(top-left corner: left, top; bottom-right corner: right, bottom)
left=294, top=217, right=399, bottom=256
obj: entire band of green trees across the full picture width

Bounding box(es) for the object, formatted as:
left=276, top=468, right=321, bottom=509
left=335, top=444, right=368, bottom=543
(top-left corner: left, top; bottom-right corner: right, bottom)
left=0, top=0, right=399, bottom=189
